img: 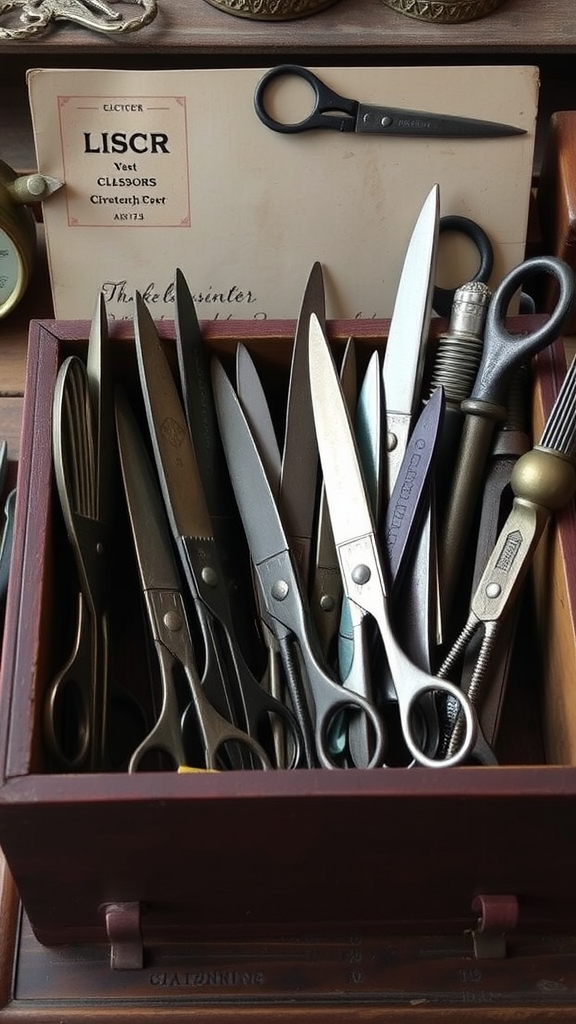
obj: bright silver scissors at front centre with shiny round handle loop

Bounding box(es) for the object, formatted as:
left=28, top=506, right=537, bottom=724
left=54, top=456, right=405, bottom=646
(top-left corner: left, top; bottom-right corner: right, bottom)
left=310, top=316, right=477, bottom=767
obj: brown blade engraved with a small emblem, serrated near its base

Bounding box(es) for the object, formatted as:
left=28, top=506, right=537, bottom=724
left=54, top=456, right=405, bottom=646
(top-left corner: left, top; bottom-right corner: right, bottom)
left=134, top=292, right=213, bottom=540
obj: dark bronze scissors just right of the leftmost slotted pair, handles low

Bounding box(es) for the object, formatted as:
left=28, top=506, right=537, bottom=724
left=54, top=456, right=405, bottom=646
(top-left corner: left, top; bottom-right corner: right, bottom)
left=116, top=389, right=272, bottom=772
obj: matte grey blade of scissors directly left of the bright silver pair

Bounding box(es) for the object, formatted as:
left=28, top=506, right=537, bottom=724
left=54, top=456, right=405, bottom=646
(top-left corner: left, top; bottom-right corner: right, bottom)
left=212, top=359, right=288, bottom=565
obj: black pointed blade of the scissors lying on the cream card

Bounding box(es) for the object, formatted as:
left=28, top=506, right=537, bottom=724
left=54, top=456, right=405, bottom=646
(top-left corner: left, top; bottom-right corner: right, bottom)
left=356, top=103, right=526, bottom=138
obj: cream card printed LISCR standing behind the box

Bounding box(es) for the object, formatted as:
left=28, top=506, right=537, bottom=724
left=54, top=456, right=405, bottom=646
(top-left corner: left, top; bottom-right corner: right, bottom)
left=28, top=67, right=538, bottom=319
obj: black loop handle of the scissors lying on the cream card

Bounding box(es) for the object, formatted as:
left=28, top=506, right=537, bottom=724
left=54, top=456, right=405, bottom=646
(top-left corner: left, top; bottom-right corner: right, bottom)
left=254, top=65, right=358, bottom=135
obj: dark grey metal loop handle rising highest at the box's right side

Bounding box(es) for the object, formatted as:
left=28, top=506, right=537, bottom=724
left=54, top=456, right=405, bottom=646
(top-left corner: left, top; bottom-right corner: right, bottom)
left=469, top=256, right=574, bottom=407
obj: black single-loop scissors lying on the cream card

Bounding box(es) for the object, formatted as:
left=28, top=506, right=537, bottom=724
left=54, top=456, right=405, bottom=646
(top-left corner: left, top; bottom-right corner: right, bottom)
left=254, top=65, right=525, bottom=138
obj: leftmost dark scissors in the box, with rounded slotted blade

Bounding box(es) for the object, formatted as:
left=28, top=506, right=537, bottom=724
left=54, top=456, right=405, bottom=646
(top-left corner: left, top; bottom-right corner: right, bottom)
left=43, top=294, right=143, bottom=771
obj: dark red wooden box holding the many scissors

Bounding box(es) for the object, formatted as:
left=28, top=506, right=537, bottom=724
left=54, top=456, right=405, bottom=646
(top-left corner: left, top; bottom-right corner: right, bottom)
left=0, top=321, right=576, bottom=1020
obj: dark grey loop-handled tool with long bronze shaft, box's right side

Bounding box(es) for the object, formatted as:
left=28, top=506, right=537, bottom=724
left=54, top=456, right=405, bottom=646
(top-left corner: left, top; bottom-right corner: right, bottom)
left=439, top=256, right=574, bottom=622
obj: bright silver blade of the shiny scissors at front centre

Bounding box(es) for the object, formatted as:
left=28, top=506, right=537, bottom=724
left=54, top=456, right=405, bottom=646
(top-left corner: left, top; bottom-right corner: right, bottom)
left=308, top=314, right=374, bottom=548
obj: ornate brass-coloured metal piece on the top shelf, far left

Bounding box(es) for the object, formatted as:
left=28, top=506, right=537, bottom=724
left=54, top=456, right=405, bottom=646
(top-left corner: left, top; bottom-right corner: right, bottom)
left=0, top=0, right=158, bottom=39
